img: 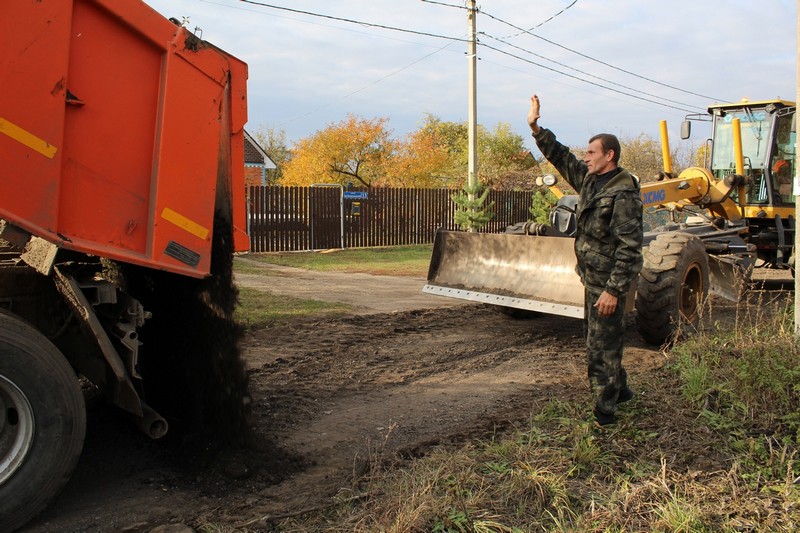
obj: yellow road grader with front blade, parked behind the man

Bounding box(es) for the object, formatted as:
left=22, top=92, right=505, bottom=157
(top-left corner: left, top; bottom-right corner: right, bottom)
left=423, top=100, right=796, bottom=344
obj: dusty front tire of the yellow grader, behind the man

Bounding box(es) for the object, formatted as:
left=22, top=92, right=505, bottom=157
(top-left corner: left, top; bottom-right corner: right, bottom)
left=636, top=232, right=709, bottom=345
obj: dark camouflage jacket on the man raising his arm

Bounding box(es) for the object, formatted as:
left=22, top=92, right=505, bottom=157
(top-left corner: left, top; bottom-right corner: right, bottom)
left=534, top=128, right=643, bottom=297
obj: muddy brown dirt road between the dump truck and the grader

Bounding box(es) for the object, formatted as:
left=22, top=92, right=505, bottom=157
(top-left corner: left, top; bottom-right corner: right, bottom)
left=24, top=262, right=780, bottom=533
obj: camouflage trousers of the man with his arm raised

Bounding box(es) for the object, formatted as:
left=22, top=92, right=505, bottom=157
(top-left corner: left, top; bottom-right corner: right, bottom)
left=583, top=290, right=628, bottom=415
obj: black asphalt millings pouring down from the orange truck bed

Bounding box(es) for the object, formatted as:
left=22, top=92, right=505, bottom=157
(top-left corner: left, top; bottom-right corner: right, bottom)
left=117, top=212, right=251, bottom=447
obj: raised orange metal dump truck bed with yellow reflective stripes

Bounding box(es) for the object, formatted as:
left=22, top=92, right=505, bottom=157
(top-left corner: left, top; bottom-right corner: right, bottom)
left=0, top=0, right=248, bottom=277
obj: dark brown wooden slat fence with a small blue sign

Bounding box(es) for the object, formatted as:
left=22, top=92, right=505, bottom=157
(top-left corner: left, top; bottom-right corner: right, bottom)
left=247, top=185, right=532, bottom=252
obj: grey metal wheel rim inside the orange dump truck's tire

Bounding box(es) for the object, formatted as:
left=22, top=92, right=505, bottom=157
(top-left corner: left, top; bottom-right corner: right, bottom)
left=0, top=376, right=34, bottom=485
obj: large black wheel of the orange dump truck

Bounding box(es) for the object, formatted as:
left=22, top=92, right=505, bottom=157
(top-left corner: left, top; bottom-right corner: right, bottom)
left=0, top=312, right=86, bottom=531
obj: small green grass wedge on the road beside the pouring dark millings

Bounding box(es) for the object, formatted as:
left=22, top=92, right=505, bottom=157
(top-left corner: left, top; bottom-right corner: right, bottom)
left=234, top=287, right=352, bottom=330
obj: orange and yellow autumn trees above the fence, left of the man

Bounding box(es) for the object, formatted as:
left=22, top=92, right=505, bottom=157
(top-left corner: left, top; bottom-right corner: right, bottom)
left=279, top=111, right=536, bottom=189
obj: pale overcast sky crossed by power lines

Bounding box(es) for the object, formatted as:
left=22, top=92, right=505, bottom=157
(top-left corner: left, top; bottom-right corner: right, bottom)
left=145, top=0, right=797, bottom=156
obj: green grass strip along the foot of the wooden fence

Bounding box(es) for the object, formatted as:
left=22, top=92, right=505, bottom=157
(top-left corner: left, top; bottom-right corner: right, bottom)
left=244, top=244, right=433, bottom=277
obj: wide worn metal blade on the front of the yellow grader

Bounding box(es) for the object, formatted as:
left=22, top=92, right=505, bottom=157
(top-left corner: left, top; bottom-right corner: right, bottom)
left=423, top=231, right=584, bottom=318
